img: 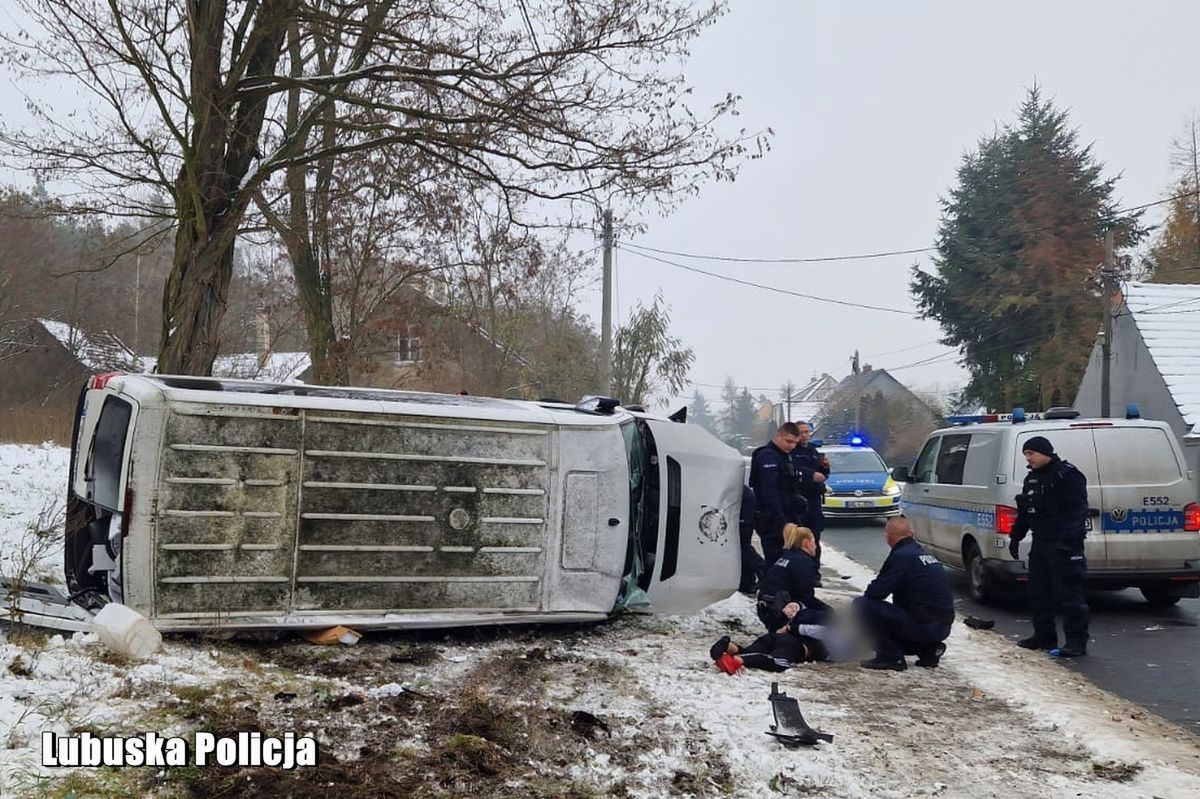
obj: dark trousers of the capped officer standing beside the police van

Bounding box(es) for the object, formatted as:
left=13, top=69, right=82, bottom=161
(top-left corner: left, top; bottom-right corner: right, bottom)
left=1028, top=535, right=1087, bottom=645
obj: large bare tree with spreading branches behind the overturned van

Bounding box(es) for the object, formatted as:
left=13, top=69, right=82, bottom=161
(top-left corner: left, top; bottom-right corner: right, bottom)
left=0, top=0, right=766, bottom=373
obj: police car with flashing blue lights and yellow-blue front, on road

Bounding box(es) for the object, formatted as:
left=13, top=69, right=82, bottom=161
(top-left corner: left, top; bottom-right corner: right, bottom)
left=818, top=435, right=900, bottom=518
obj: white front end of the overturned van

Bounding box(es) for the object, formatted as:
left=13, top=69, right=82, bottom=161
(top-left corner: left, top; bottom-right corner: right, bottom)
left=646, top=419, right=745, bottom=613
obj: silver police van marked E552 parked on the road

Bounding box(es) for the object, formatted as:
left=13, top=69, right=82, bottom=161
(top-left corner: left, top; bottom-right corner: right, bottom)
left=893, top=405, right=1200, bottom=606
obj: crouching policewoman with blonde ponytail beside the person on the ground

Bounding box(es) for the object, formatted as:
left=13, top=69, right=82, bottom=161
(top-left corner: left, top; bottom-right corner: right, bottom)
left=755, top=524, right=833, bottom=632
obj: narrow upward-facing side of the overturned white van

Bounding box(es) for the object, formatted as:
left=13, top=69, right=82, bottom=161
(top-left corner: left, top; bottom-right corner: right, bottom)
left=109, top=374, right=632, bottom=426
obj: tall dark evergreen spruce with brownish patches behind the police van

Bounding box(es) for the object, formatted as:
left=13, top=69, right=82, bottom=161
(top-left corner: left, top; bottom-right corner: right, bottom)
left=912, top=86, right=1145, bottom=409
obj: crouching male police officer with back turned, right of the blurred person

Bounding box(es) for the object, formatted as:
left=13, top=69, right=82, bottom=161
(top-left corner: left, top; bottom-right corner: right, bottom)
left=853, top=516, right=954, bottom=672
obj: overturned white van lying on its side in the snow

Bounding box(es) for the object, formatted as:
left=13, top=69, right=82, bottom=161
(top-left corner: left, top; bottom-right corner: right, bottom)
left=51, top=374, right=743, bottom=630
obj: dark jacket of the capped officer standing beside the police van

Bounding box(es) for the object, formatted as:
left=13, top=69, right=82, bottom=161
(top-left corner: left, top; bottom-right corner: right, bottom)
left=1012, top=455, right=1087, bottom=543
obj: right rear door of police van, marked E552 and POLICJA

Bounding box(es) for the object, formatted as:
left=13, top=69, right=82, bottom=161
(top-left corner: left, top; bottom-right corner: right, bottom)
left=1093, top=426, right=1200, bottom=569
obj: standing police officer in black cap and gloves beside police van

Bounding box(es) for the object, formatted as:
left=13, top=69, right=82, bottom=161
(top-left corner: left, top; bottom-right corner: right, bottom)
left=1008, top=435, right=1087, bottom=657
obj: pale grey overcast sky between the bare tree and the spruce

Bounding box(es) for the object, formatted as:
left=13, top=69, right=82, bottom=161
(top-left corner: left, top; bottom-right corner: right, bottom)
left=593, top=0, right=1200, bottom=400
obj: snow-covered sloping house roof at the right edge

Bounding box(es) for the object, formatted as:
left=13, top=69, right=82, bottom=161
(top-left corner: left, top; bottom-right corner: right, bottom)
left=1122, top=282, right=1200, bottom=425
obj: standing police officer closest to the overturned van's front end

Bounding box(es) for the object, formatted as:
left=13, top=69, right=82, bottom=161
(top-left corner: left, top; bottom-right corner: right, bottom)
left=750, top=422, right=804, bottom=564
